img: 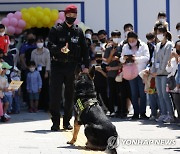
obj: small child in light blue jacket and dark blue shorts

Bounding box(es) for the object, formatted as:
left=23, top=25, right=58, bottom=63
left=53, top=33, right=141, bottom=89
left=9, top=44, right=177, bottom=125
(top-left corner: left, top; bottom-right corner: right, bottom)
left=26, top=61, right=42, bottom=113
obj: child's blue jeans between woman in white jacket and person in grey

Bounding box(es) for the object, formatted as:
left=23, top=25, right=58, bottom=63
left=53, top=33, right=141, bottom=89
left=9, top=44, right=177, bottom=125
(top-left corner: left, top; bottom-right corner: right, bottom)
left=149, top=94, right=160, bottom=116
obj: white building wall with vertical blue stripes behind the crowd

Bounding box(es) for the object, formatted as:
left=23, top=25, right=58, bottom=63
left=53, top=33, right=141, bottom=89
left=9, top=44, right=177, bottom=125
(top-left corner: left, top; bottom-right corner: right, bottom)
left=0, top=0, right=180, bottom=41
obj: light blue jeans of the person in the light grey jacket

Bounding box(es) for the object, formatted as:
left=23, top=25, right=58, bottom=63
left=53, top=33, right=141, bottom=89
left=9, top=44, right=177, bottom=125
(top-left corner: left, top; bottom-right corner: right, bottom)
left=155, top=76, right=173, bottom=115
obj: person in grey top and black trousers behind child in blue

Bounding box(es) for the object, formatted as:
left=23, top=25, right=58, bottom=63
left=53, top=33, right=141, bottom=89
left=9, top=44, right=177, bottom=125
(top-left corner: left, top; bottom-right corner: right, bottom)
left=31, top=37, right=50, bottom=111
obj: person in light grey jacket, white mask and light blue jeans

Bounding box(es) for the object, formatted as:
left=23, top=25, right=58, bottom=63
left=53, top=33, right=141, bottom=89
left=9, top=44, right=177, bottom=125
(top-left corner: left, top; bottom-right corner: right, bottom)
left=151, top=26, right=174, bottom=122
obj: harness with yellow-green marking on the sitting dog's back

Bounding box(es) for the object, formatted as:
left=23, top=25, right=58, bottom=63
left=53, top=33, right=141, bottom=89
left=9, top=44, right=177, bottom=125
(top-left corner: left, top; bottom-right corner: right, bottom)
left=75, top=98, right=98, bottom=120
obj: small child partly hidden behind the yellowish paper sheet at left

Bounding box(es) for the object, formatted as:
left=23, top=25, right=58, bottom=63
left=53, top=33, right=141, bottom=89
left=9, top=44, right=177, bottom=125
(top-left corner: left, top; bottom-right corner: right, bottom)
left=10, top=66, right=21, bottom=114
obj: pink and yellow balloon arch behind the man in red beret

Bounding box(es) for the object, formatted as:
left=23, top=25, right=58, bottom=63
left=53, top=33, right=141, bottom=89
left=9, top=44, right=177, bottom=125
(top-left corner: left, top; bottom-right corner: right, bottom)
left=1, top=6, right=88, bottom=35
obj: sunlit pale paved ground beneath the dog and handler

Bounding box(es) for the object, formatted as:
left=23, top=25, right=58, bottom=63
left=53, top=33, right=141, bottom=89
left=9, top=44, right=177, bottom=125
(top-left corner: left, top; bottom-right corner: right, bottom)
left=0, top=107, right=180, bottom=154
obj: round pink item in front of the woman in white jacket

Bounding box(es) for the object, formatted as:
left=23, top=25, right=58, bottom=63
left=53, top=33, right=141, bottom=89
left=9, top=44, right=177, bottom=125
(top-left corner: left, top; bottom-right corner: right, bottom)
left=122, top=63, right=138, bottom=80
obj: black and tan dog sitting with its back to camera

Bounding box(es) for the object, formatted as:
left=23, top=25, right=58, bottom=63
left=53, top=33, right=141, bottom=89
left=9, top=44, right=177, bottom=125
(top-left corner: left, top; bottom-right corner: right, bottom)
left=68, top=73, right=118, bottom=153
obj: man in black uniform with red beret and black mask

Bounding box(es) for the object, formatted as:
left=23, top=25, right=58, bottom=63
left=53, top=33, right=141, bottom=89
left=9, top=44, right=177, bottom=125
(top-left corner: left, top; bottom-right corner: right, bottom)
left=49, top=5, right=89, bottom=131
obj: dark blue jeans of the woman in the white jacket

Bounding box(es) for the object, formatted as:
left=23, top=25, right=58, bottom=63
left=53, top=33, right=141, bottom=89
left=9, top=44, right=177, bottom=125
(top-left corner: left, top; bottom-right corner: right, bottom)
left=129, top=76, right=146, bottom=115
